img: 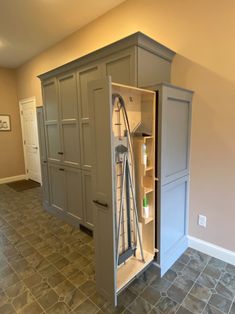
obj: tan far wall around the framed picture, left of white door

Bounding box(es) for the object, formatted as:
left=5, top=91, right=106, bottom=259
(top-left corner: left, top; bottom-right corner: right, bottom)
left=0, top=68, right=25, bottom=179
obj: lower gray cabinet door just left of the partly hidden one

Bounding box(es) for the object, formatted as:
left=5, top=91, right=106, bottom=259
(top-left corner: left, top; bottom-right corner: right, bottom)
left=66, top=167, right=83, bottom=221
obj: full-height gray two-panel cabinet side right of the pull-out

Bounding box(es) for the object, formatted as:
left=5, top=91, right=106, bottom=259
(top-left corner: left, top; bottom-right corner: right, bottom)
left=156, top=84, right=192, bottom=275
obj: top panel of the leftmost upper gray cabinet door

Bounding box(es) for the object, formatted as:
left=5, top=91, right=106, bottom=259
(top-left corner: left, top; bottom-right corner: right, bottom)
left=42, top=79, right=58, bottom=121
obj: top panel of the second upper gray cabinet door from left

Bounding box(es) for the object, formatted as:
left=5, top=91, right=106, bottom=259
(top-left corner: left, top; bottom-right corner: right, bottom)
left=58, top=73, right=77, bottom=120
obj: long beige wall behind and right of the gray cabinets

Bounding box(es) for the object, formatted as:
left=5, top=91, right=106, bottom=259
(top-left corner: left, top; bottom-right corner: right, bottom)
left=18, top=0, right=235, bottom=251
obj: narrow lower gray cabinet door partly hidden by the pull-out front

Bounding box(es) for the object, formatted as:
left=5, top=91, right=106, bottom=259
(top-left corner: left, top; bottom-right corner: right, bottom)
left=82, top=171, right=94, bottom=229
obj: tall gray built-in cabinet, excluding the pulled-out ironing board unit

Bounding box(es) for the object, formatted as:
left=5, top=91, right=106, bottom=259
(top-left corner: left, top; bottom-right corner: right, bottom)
left=39, top=32, right=192, bottom=301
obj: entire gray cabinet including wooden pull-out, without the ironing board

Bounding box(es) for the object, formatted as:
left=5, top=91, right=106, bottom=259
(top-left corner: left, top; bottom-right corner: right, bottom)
left=39, top=33, right=192, bottom=284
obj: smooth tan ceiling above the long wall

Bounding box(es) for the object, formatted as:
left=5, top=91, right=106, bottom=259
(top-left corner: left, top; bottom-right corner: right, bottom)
left=0, top=0, right=124, bottom=68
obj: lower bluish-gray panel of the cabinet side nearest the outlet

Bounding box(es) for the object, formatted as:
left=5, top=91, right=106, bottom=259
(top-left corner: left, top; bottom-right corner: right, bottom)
left=158, top=176, right=188, bottom=275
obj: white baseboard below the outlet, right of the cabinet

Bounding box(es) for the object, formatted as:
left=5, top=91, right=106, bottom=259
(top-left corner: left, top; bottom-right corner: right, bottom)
left=188, top=236, right=235, bottom=265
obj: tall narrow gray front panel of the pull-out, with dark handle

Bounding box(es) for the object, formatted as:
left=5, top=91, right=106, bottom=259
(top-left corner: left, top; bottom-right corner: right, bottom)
left=88, top=78, right=117, bottom=305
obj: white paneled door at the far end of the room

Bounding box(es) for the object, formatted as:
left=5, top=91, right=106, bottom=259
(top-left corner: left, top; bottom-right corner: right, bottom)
left=20, top=98, right=41, bottom=183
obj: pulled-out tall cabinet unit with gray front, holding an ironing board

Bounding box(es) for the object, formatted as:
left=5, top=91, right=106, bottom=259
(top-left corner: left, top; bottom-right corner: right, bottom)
left=89, top=77, right=155, bottom=305
